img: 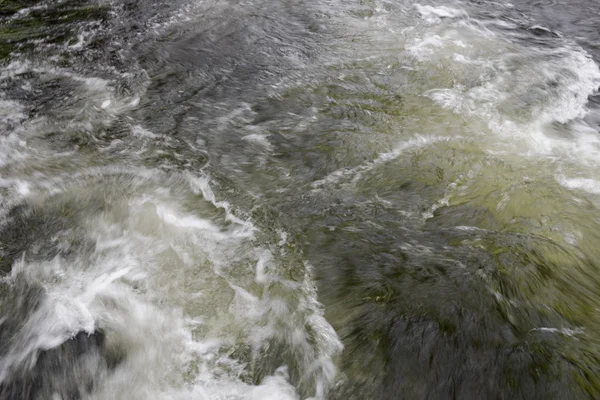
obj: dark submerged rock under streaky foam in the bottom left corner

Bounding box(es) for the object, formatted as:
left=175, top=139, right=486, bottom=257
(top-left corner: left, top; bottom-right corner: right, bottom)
left=0, top=280, right=124, bottom=400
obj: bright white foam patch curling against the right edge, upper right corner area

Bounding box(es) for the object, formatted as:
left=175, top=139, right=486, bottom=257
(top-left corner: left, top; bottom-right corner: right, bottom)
left=406, top=6, right=600, bottom=169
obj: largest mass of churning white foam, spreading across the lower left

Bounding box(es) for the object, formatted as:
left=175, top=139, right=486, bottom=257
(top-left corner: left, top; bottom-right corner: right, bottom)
left=0, top=168, right=341, bottom=400
